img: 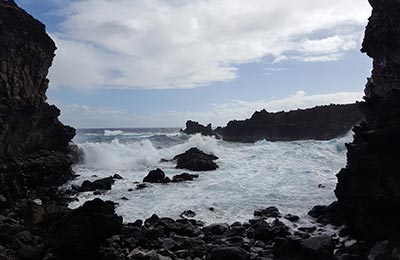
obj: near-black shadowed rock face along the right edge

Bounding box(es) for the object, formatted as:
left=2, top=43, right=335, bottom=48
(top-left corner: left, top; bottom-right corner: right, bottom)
left=335, top=0, right=400, bottom=241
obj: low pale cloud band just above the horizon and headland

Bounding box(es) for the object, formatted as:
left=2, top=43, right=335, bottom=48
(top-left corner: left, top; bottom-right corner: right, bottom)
left=59, top=90, right=363, bottom=128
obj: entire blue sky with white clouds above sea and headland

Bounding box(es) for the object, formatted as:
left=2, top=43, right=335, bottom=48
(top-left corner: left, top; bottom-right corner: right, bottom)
left=16, top=0, right=371, bottom=128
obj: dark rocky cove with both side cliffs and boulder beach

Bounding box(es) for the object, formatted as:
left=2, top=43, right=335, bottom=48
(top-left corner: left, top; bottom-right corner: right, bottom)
left=0, top=0, right=400, bottom=260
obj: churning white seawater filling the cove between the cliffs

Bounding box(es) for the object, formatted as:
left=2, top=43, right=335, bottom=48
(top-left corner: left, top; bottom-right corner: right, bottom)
left=68, top=128, right=352, bottom=223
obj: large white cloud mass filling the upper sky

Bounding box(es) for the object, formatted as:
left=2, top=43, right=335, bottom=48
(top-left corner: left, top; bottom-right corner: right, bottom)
left=50, top=0, right=370, bottom=89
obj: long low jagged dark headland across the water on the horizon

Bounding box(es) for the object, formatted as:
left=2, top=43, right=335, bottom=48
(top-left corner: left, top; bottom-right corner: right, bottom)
left=183, top=104, right=363, bottom=143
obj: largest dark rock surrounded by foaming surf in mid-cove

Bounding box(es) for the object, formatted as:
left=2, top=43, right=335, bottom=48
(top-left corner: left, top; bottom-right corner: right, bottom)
left=174, top=147, right=218, bottom=171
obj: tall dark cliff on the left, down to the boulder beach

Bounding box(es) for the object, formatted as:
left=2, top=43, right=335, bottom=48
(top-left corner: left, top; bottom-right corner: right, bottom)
left=0, top=0, right=75, bottom=205
